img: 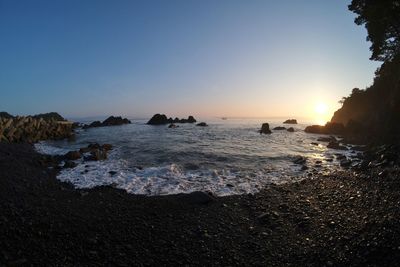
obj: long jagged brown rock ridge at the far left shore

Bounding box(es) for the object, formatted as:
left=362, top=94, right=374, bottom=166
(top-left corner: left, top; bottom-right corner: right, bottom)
left=0, top=116, right=73, bottom=143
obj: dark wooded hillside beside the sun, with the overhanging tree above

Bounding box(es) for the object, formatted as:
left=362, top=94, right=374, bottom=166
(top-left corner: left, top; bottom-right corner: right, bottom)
left=331, top=0, right=400, bottom=142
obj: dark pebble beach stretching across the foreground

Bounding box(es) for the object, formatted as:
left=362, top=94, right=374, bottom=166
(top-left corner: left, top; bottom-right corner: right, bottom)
left=0, top=143, right=400, bottom=266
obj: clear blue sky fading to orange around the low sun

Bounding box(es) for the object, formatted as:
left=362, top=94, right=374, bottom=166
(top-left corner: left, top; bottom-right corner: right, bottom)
left=0, top=0, right=379, bottom=121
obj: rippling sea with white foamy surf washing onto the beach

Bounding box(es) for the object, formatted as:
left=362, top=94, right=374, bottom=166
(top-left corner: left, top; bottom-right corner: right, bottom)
left=35, top=119, right=355, bottom=196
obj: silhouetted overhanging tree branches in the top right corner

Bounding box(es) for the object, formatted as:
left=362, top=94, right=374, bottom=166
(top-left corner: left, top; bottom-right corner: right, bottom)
left=349, top=0, right=400, bottom=61
